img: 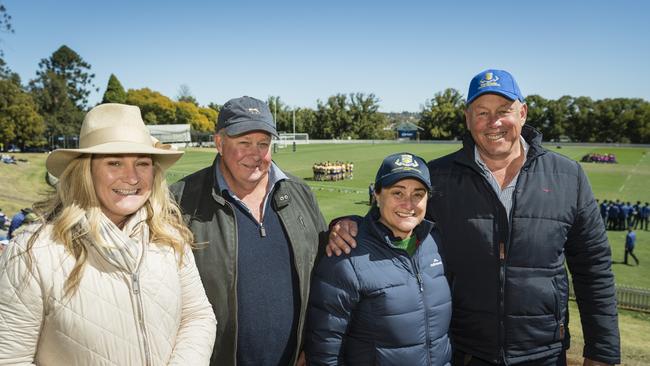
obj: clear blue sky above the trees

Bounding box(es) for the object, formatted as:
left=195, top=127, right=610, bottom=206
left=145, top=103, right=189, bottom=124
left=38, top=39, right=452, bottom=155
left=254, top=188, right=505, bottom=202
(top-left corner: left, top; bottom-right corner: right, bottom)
left=0, top=0, right=650, bottom=112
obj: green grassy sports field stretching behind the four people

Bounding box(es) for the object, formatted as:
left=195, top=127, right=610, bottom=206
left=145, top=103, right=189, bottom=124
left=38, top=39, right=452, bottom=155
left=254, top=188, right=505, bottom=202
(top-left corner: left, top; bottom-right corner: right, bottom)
left=0, top=143, right=650, bottom=365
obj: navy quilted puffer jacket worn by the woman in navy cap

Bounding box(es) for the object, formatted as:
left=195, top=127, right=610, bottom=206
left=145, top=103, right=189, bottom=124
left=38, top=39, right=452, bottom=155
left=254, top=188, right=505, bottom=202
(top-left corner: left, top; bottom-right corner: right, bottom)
left=305, top=210, right=451, bottom=365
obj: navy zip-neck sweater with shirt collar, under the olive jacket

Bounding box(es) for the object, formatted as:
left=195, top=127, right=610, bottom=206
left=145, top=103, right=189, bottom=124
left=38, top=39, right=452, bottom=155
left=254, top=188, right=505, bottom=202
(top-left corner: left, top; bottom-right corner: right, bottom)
left=215, top=156, right=300, bottom=366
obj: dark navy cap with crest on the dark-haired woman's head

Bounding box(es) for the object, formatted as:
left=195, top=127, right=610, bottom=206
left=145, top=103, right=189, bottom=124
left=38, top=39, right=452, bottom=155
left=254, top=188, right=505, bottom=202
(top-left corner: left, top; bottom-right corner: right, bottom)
left=375, top=152, right=431, bottom=191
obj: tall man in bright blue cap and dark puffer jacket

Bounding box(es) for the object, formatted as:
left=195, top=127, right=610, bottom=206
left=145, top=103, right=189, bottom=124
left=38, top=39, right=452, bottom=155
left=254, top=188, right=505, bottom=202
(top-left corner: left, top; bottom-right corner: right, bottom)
left=329, top=70, right=620, bottom=366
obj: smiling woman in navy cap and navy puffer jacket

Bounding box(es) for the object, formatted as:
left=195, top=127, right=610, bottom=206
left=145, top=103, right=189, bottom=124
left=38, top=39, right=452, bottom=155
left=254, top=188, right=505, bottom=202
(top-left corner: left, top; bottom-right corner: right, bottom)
left=305, top=153, right=451, bottom=365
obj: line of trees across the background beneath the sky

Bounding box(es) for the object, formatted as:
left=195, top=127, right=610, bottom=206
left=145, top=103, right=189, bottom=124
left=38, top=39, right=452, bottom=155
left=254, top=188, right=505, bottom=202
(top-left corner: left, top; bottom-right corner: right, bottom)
left=0, top=4, right=650, bottom=148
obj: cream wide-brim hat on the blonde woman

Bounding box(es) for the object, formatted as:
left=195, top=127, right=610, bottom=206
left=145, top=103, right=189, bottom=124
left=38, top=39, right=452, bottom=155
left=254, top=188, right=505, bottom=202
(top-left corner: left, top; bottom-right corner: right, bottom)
left=45, top=103, right=183, bottom=178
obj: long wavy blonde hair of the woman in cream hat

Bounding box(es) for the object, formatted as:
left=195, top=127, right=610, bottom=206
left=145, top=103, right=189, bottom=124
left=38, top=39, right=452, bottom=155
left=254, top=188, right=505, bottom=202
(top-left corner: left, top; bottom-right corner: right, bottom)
left=25, top=154, right=194, bottom=296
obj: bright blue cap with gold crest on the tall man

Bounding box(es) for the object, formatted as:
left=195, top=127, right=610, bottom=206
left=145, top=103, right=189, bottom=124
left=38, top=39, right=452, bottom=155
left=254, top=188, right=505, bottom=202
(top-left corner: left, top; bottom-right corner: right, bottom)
left=466, top=69, right=524, bottom=105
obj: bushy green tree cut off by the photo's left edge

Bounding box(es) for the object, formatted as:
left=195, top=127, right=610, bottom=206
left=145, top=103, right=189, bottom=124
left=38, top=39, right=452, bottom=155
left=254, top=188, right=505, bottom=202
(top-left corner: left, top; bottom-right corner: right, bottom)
left=0, top=80, right=45, bottom=147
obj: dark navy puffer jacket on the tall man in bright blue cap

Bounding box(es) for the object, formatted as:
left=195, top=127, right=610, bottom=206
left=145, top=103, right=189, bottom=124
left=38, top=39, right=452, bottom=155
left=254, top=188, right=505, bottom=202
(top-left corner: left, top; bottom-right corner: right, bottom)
left=427, top=126, right=620, bottom=364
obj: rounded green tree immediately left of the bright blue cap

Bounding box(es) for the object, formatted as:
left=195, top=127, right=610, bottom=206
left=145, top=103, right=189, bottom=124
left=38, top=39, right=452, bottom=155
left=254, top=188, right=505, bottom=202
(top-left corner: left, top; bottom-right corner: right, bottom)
left=419, top=88, right=467, bottom=140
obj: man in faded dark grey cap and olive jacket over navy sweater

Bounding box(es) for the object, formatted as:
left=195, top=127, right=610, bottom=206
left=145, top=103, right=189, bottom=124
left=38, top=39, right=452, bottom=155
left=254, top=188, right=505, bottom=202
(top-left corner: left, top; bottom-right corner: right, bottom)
left=171, top=96, right=327, bottom=366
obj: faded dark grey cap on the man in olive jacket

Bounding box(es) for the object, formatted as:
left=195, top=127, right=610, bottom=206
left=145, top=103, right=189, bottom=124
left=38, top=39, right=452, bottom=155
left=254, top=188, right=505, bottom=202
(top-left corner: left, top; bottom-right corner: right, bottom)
left=217, top=96, right=278, bottom=137
